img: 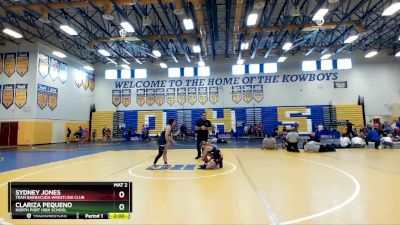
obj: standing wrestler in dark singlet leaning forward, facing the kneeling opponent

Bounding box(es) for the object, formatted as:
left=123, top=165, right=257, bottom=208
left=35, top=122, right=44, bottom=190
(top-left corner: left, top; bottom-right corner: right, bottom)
left=151, top=119, right=176, bottom=169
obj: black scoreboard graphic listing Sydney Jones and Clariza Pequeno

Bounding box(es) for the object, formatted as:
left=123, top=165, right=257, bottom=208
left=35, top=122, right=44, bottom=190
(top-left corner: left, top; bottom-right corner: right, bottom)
left=8, top=182, right=132, bottom=219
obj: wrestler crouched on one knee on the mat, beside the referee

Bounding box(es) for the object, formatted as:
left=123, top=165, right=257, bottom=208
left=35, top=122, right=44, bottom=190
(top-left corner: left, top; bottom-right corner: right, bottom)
left=199, top=141, right=224, bottom=170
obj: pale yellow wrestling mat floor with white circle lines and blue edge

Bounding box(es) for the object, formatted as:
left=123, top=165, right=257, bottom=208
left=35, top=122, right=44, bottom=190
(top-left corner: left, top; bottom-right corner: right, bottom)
left=0, top=140, right=400, bottom=224
